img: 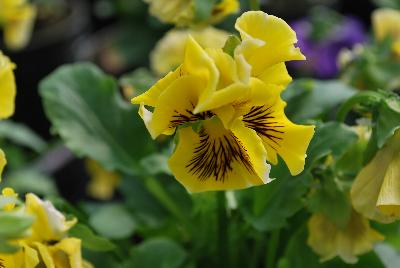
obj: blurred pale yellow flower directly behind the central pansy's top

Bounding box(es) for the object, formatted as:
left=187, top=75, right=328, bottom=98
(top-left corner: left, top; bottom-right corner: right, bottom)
left=150, top=27, right=229, bottom=76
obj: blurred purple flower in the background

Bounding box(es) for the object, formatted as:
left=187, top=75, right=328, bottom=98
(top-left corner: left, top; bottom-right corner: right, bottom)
left=290, top=17, right=367, bottom=78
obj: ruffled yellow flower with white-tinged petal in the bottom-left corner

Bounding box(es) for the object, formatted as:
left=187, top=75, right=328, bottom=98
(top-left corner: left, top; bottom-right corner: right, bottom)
left=0, top=193, right=92, bottom=268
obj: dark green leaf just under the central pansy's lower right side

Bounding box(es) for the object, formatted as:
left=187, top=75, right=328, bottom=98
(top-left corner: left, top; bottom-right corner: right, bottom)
left=235, top=161, right=312, bottom=231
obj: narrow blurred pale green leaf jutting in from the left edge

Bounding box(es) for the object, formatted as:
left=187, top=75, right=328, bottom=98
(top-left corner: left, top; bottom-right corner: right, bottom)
left=0, top=120, right=47, bottom=153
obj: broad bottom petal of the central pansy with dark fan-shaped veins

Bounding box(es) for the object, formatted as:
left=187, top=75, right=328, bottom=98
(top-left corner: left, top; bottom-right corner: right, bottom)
left=169, top=118, right=270, bottom=193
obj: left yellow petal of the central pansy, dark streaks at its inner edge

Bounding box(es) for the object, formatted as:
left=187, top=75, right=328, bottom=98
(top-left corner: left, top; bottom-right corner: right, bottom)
left=147, top=75, right=206, bottom=138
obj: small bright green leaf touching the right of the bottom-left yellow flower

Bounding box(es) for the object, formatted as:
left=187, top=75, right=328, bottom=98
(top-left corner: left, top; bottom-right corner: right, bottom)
left=68, top=223, right=115, bottom=251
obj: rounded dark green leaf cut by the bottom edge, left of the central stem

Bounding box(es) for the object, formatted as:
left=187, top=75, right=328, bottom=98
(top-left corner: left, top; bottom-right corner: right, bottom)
left=129, top=238, right=187, bottom=268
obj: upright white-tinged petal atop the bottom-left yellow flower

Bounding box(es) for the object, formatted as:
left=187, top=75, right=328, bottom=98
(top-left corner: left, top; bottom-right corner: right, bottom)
left=25, top=193, right=76, bottom=241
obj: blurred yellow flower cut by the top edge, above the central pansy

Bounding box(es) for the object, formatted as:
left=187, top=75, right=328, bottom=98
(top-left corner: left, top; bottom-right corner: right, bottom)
left=144, top=0, right=239, bottom=26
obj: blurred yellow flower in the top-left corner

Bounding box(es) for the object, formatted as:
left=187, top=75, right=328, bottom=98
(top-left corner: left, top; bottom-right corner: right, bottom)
left=0, top=0, right=36, bottom=50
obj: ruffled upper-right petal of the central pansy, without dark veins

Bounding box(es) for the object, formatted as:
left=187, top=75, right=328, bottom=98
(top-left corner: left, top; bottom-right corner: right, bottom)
left=235, top=11, right=305, bottom=77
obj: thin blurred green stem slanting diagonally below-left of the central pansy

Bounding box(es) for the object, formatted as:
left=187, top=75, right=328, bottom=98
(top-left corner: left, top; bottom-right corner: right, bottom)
left=146, top=177, right=188, bottom=223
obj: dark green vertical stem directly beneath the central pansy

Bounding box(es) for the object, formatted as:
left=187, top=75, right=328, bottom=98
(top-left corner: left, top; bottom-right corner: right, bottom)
left=217, top=191, right=229, bottom=267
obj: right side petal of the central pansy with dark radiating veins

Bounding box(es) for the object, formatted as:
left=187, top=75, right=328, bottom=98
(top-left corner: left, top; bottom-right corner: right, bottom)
left=243, top=83, right=314, bottom=175
